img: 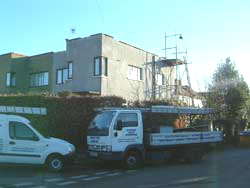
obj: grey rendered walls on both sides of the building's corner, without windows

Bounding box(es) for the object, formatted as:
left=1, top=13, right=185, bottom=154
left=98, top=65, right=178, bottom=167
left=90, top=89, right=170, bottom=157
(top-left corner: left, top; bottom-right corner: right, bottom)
left=52, top=34, right=175, bottom=101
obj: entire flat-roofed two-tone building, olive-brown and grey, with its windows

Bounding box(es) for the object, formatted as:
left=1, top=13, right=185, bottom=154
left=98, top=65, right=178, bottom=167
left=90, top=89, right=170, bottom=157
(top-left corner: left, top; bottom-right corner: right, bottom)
left=0, top=34, right=175, bottom=101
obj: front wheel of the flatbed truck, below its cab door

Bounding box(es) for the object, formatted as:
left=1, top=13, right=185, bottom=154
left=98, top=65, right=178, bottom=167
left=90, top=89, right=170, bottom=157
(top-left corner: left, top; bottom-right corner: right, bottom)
left=124, top=151, right=143, bottom=169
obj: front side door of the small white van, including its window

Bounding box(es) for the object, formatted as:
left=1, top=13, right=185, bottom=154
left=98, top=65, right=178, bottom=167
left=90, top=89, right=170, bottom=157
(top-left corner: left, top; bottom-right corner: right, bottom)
left=6, top=121, right=46, bottom=164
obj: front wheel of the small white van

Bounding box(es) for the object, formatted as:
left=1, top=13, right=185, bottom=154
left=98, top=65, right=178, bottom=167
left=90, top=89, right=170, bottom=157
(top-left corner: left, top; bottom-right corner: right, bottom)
left=46, top=155, right=64, bottom=172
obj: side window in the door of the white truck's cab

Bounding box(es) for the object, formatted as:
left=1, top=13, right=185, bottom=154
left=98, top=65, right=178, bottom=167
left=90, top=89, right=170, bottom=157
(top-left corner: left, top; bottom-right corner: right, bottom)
left=116, top=113, right=138, bottom=127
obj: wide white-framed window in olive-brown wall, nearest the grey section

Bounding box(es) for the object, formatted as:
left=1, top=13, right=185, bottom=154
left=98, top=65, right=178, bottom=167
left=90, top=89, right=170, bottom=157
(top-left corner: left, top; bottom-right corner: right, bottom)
left=30, top=72, right=49, bottom=87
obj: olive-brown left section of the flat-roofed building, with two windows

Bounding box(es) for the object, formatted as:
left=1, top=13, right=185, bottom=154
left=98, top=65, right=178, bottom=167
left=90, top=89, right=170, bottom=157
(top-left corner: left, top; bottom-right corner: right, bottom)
left=0, top=52, right=53, bottom=94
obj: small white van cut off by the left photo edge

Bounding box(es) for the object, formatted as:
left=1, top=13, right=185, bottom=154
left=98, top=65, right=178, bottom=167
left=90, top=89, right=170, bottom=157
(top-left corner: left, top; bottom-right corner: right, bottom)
left=0, top=114, right=75, bottom=171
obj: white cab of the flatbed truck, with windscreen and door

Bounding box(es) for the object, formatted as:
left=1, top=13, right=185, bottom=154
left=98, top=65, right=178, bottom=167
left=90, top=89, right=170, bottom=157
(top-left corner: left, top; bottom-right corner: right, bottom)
left=87, top=110, right=143, bottom=160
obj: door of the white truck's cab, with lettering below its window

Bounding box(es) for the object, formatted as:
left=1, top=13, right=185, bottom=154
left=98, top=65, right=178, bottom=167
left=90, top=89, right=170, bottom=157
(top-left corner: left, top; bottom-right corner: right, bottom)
left=111, top=112, right=142, bottom=152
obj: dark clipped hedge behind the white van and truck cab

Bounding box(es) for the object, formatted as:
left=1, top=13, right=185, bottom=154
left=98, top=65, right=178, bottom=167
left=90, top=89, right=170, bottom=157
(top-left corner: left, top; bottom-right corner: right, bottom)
left=0, top=96, right=125, bottom=150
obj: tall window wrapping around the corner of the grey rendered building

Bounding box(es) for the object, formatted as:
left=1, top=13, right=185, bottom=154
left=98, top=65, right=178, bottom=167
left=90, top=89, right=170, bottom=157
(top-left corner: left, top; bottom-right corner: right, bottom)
left=94, top=57, right=108, bottom=76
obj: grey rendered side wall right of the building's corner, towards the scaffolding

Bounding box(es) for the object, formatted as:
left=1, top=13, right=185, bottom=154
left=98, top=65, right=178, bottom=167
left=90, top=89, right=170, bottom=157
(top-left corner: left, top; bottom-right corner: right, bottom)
left=101, top=35, right=174, bottom=101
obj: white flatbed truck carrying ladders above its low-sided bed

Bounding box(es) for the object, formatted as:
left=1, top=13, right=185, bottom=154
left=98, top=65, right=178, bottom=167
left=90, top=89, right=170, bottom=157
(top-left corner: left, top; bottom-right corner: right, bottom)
left=87, top=106, right=223, bottom=169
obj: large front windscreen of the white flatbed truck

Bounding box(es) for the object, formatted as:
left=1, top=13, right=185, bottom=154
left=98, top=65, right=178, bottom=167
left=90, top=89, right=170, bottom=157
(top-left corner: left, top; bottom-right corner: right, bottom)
left=88, top=111, right=116, bottom=136
